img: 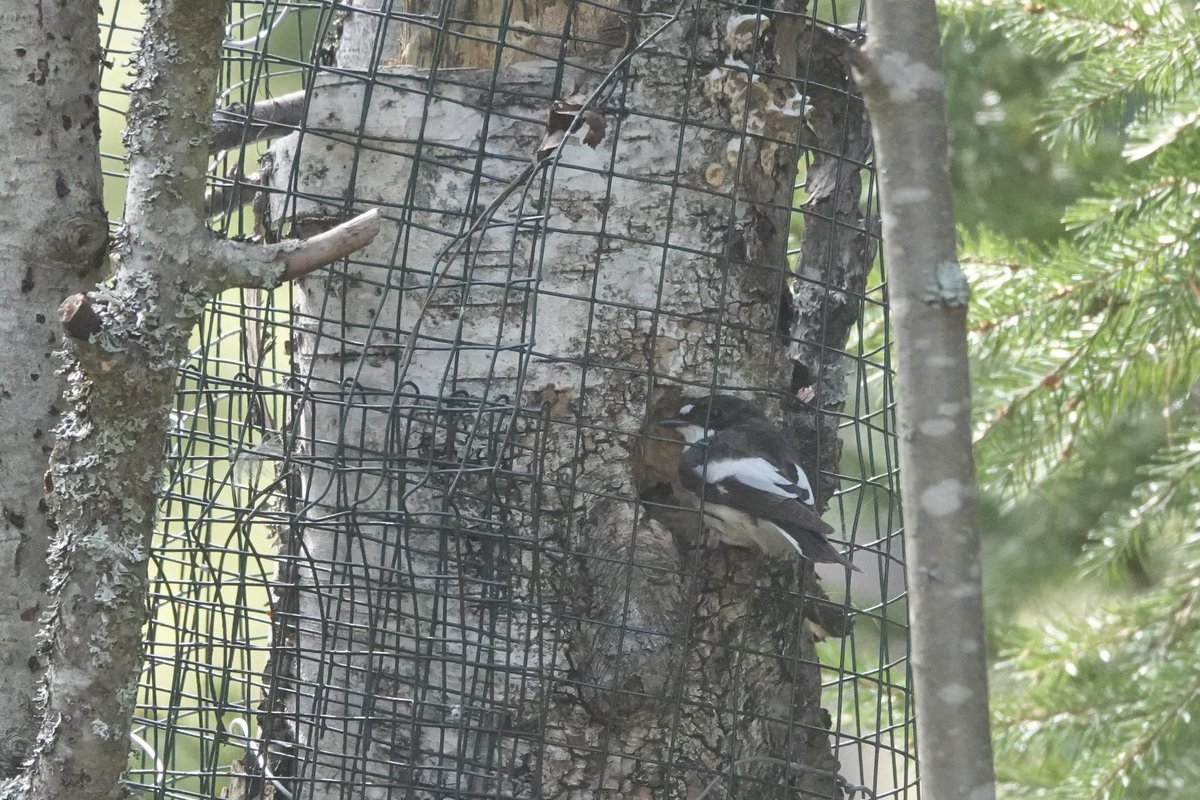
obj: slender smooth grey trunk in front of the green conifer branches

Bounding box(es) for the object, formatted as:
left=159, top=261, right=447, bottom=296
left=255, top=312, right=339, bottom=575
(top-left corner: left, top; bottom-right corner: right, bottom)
left=859, top=0, right=995, bottom=800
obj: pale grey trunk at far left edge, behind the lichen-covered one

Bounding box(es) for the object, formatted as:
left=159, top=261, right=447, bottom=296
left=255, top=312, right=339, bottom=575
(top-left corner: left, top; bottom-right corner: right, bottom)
left=0, top=2, right=108, bottom=780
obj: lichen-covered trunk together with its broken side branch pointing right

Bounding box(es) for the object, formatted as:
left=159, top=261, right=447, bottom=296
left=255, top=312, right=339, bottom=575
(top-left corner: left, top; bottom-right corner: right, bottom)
left=0, top=0, right=371, bottom=800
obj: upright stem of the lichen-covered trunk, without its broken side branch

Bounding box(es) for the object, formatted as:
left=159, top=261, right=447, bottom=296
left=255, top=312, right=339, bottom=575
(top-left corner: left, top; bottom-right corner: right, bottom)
left=8, top=0, right=232, bottom=798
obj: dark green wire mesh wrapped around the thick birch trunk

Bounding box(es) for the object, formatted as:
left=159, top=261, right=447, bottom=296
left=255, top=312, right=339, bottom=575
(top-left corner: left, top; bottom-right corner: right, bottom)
left=101, top=0, right=918, bottom=798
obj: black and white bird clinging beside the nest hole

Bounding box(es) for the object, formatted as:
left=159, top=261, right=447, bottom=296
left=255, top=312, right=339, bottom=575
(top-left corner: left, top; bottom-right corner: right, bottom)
left=660, top=395, right=858, bottom=571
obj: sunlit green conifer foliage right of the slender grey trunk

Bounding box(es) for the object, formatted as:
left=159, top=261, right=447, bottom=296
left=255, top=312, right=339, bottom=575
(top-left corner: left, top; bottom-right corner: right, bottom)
left=946, top=0, right=1200, bottom=799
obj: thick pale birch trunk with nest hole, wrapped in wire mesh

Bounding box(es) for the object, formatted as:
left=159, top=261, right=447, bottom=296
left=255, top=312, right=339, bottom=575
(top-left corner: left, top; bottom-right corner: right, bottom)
left=246, top=2, right=865, bottom=798
